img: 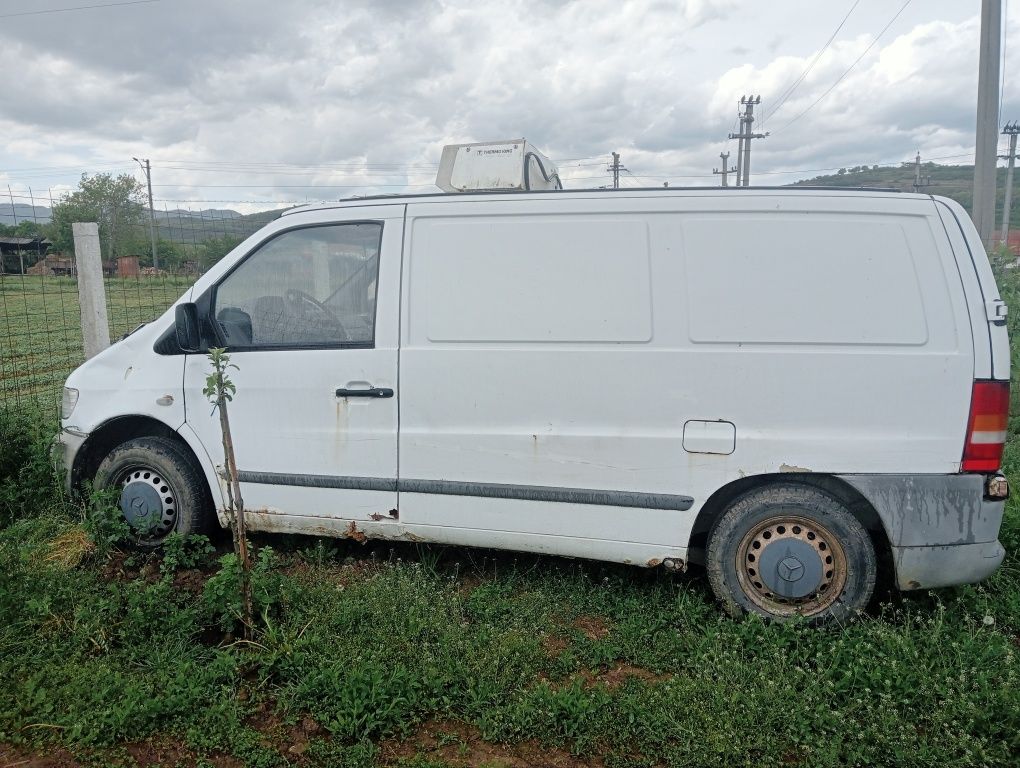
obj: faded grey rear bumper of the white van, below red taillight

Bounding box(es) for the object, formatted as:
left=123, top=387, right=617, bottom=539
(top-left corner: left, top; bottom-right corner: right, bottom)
left=842, top=474, right=1006, bottom=590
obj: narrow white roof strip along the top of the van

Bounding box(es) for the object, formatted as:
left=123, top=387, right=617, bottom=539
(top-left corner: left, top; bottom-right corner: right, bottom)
left=281, top=186, right=932, bottom=216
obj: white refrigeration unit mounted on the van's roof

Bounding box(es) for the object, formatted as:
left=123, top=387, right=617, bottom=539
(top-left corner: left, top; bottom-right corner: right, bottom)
left=436, top=139, right=563, bottom=192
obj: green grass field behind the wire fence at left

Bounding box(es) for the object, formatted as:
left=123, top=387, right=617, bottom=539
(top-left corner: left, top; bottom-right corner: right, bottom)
left=0, top=274, right=194, bottom=403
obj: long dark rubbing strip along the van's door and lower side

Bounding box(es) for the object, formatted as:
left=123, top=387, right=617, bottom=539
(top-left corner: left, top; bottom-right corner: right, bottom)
left=238, top=472, right=695, bottom=512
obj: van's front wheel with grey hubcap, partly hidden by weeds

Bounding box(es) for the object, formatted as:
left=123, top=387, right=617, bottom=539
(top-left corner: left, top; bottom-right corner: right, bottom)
left=94, top=438, right=210, bottom=550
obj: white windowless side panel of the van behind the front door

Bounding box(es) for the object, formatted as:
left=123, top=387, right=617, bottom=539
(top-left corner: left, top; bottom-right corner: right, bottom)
left=399, top=194, right=974, bottom=559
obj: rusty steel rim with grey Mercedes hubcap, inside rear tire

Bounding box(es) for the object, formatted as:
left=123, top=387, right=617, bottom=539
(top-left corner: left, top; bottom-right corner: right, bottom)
left=735, top=515, right=847, bottom=616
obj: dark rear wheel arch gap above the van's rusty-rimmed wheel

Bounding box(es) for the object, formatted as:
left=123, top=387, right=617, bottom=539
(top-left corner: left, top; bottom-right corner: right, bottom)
left=687, top=472, right=891, bottom=570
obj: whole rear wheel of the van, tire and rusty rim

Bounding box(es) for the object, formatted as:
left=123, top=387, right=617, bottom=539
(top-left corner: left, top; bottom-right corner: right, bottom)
left=706, top=483, right=877, bottom=623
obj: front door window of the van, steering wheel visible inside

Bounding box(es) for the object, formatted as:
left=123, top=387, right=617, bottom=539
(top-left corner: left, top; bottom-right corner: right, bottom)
left=214, top=222, right=383, bottom=349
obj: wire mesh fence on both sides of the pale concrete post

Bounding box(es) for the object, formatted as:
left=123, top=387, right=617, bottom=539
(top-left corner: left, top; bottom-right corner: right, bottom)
left=0, top=192, right=279, bottom=407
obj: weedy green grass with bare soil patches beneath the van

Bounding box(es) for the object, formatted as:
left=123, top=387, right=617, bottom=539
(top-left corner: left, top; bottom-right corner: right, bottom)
left=0, top=273, right=1020, bottom=768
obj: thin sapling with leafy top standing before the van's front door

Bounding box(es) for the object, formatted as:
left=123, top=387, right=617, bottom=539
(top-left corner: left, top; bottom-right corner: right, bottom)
left=202, top=347, right=253, bottom=637
